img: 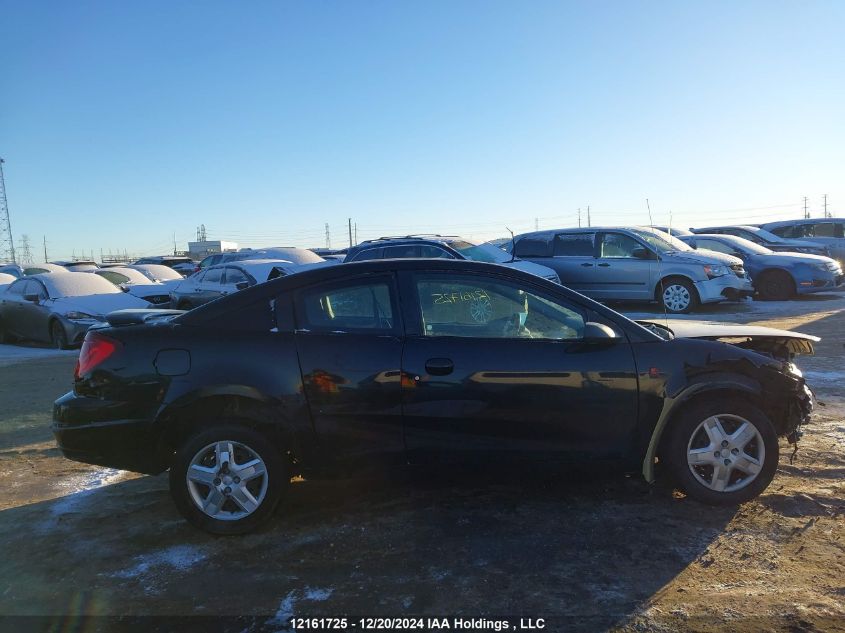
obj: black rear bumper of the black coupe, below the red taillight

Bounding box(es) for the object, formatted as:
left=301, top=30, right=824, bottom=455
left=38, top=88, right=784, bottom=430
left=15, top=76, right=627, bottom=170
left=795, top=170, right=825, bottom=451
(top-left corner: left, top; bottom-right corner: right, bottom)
left=52, top=392, right=167, bottom=474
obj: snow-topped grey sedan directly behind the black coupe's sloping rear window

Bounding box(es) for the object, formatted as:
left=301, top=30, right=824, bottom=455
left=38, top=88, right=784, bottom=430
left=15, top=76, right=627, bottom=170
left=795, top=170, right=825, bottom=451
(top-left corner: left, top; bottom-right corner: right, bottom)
left=170, top=258, right=304, bottom=310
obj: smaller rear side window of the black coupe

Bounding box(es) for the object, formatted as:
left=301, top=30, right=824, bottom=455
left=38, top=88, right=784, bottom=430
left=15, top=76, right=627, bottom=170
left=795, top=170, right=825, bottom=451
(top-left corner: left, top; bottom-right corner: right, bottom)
left=296, top=279, right=397, bottom=333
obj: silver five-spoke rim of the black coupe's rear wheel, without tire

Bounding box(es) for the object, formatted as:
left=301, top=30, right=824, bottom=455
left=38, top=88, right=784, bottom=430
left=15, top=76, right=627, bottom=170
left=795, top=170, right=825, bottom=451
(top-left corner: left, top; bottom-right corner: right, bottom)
left=185, top=440, right=270, bottom=521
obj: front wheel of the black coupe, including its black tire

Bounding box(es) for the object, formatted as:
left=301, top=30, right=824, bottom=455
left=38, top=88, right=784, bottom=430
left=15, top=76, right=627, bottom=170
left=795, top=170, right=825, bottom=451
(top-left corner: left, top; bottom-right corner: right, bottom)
left=664, top=400, right=778, bottom=506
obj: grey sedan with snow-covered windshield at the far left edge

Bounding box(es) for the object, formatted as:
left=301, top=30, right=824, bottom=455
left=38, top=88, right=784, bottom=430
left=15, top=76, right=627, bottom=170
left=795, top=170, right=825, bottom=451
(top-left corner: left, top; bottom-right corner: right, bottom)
left=0, top=272, right=151, bottom=349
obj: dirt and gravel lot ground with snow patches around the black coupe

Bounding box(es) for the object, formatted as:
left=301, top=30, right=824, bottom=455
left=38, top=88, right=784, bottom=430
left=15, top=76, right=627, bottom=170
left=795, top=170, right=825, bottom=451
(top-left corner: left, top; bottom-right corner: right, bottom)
left=0, top=294, right=845, bottom=631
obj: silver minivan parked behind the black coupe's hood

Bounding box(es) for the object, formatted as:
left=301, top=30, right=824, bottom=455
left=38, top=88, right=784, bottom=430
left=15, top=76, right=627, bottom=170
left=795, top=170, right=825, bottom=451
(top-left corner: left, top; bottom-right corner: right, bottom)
left=507, top=227, right=754, bottom=313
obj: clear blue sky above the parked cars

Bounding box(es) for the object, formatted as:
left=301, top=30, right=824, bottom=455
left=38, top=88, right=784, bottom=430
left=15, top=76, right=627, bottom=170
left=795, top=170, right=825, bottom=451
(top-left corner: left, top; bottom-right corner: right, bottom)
left=0, top=0, right=845, bottom=259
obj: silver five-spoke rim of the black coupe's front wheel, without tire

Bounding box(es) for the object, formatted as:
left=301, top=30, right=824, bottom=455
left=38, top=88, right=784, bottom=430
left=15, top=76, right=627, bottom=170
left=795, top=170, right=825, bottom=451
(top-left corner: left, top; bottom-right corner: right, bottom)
left=687, top=414, right=766, bottom=492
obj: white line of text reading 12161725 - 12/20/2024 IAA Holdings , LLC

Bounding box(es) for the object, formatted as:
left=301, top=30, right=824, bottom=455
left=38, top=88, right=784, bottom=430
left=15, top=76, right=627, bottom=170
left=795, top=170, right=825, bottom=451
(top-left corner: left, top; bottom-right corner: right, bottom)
left=289, top=617, right=546, bottom=632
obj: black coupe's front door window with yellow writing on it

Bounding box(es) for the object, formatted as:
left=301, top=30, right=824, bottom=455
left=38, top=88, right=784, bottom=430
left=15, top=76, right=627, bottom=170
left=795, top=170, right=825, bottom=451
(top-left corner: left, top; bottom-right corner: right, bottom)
left=415, top=274, right=585, bottom=340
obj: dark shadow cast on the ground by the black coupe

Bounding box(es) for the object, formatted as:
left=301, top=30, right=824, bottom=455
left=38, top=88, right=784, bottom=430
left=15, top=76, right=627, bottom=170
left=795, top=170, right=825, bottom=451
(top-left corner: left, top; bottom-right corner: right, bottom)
left=0, top=462, right=734, bottom=629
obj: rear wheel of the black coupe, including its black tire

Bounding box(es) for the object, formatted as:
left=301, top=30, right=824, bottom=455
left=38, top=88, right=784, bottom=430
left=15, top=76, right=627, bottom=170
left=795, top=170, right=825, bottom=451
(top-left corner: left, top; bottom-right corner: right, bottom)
left=170, top=422, right=290, bottom=535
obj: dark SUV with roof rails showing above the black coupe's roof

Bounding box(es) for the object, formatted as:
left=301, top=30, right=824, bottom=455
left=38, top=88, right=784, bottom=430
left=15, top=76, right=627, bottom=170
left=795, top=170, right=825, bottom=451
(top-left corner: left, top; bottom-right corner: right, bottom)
left=343, top=233, right=560, bottom=283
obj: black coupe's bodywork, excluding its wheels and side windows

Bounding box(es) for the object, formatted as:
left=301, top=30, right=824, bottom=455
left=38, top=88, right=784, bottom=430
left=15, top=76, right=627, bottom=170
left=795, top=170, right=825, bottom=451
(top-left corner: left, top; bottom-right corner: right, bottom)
left=53, top=260, right=811, bottom=478
